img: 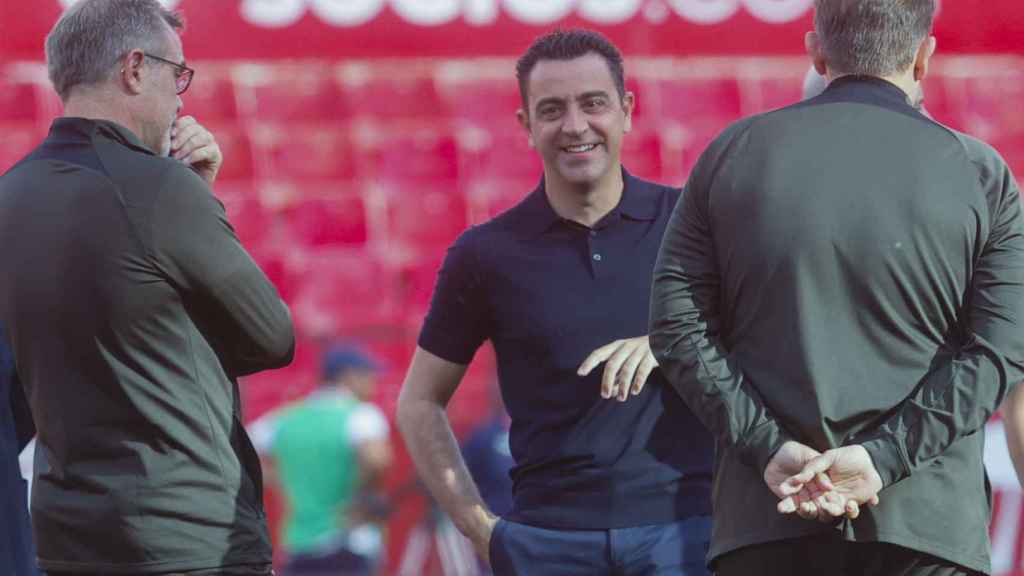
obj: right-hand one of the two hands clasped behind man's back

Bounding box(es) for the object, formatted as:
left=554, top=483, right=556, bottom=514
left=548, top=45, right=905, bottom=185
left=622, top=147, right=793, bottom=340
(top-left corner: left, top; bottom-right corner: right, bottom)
left=766, top=445, right=882, bottom=518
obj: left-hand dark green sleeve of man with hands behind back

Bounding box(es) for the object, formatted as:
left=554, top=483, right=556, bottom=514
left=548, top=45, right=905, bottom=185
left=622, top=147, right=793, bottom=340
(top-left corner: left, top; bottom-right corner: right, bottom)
left=650, top=127, right=791, bottom=471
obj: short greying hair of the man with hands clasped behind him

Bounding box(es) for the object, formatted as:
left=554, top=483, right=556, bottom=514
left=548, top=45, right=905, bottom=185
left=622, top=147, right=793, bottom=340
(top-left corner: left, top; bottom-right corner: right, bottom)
left=814, top=0, right=935, bottom=76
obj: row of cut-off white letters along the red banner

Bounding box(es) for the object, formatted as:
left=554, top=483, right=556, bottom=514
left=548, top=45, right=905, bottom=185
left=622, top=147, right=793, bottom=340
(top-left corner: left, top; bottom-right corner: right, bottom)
left=234, top=0, right=814, bottom=28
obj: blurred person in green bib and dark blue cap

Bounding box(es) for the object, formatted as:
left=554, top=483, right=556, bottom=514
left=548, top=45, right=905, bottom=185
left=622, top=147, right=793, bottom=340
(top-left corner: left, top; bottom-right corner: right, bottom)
left=250, top=344, right=392, bottom=576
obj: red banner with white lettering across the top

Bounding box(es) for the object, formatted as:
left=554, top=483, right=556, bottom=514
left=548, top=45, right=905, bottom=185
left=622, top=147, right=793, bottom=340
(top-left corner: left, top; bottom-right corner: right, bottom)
left=0, top=0, right=1024, bottom=60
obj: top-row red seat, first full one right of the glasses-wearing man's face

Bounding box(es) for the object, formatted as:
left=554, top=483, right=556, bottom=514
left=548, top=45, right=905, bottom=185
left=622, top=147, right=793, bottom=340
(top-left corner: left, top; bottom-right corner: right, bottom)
left=234, top=63, right=348, bottom=124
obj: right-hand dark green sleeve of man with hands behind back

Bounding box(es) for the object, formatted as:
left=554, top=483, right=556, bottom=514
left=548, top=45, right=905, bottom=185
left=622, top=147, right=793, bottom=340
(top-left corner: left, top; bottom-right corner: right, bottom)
left=853, top=140, right=1024, bottom=486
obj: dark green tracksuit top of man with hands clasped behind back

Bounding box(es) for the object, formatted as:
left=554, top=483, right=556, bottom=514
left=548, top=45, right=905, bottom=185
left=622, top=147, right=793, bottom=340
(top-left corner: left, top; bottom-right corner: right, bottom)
left=651, top=77, right=1024, bottom=572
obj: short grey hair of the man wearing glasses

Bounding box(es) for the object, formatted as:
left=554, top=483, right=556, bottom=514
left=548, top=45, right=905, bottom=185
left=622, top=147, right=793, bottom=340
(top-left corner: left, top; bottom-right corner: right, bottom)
left=46, top=0, right=183, bottom=100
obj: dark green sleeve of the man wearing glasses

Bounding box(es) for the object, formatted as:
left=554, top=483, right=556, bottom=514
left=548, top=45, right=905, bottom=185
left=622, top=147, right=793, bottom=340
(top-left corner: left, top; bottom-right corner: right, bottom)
left=151, top=167, right=295, bottom=376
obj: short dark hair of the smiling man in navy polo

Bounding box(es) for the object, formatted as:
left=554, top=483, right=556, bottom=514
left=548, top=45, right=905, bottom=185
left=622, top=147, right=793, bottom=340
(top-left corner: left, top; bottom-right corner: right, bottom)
left=515, top=29, right=626, bottom=110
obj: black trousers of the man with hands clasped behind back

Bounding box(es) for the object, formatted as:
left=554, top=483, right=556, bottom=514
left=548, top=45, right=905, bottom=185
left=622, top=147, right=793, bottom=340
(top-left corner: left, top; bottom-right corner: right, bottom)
left=715, top=532, right=981, bottom=576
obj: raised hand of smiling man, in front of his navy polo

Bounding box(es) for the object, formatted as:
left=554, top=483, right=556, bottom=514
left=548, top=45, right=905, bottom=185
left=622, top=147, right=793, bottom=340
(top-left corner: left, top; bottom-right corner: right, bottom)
left=577, top=336, right=657, bottom=402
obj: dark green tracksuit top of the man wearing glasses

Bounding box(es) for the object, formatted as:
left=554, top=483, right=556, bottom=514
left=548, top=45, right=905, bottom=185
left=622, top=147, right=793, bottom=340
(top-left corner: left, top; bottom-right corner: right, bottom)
left=0, top=118, right=294, bottom=574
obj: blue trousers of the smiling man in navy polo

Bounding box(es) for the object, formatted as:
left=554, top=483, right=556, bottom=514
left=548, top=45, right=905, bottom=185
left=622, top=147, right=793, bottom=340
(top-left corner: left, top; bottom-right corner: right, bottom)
left=490, top=517, right=711, bottom=576
